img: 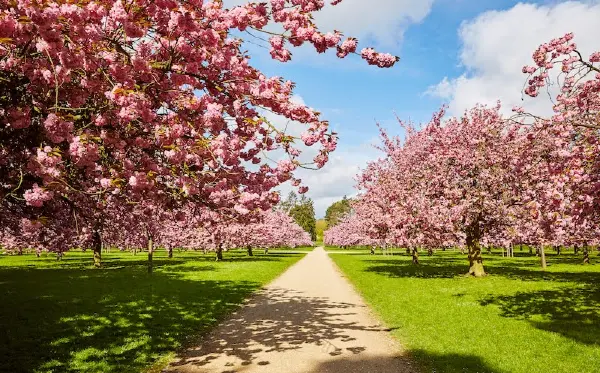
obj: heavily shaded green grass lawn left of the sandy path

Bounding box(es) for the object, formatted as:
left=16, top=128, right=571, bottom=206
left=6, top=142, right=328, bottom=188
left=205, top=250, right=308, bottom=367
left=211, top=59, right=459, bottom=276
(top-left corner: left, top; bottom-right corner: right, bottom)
left=0, top=247, right=303, bottom=372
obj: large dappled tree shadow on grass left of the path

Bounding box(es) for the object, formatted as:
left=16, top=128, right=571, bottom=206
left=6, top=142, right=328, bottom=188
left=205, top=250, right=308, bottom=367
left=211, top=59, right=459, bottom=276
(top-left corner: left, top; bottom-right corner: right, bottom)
left=0, top=260, right=268, bottom=372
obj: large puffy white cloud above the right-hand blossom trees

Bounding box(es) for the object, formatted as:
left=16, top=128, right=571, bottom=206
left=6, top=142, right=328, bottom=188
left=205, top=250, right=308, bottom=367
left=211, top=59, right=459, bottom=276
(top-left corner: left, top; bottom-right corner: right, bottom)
left=426, top=1, right=600, bottom=115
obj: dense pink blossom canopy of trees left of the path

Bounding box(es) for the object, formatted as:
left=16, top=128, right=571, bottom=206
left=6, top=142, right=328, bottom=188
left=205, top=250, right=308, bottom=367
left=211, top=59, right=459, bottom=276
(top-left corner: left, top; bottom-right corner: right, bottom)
left=0, top=0, right=398, bottom=264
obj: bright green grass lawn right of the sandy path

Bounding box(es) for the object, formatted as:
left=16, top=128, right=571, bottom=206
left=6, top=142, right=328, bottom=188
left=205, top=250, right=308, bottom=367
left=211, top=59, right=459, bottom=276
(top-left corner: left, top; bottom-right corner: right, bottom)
left=331, top=247, right=600, bottom=373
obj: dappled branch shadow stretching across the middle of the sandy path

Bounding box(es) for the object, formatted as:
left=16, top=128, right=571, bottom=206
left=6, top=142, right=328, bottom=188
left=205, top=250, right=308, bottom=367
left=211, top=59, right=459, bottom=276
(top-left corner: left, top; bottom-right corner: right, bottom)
left=169, top=288, right=391, bottom=372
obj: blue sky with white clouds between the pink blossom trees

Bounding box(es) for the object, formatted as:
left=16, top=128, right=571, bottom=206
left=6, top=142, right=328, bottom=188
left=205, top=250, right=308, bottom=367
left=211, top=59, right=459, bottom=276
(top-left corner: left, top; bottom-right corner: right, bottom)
left=229, top=0, right=600, bottom=216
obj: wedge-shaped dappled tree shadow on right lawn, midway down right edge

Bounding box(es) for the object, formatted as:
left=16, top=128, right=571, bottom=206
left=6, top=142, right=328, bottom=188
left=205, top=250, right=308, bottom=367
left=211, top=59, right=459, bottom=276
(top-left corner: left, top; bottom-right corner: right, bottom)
left=480, top=285, right=600, bottom=346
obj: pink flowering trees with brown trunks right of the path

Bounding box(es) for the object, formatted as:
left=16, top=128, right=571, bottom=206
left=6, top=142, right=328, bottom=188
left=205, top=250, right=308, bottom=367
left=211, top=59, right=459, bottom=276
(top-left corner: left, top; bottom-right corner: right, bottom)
left=325, top=34, right=600, bottom=276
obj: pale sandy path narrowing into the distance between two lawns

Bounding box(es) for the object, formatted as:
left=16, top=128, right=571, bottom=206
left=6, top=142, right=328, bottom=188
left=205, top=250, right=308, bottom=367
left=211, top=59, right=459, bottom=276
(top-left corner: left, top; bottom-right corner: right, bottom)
left=165, top=247, right=417, bottom=373
